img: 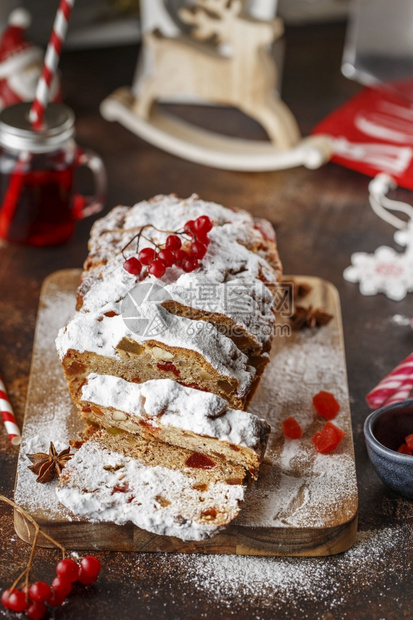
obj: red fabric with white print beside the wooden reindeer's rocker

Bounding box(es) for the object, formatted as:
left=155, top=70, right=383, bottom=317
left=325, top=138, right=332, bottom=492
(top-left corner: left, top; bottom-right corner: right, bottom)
left=312, top=83, right=413, bottom=189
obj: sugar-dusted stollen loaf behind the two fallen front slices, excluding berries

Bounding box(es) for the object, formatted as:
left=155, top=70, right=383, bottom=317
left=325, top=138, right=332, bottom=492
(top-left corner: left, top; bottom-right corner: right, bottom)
left=57, top=195, right=281, bottom=409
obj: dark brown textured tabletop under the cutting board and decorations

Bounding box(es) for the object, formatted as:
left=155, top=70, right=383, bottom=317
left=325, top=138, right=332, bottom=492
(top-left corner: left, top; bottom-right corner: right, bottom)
left=0, top=24, right=413, bottom=620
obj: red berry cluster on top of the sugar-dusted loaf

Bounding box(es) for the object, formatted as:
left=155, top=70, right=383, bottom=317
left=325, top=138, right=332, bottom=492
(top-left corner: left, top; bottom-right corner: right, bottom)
left=123, top=215, right=212, bottom=278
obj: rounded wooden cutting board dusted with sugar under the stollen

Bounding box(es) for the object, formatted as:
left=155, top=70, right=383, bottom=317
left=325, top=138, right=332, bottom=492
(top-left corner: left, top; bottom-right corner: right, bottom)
left=15, top=269, right=358, bottom=556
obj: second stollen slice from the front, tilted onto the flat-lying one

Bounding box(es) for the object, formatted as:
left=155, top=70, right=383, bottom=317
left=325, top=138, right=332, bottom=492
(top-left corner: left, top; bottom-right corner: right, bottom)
left=79, top=374, right=270, bottom=478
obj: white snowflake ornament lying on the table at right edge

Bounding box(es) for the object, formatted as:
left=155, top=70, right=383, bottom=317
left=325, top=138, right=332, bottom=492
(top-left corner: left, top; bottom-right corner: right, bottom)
left=343, top=245, right=413, bottom=301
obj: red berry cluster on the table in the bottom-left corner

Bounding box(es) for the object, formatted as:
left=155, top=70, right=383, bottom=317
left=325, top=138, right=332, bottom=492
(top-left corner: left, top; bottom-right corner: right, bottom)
left=1, top=555, right=100, bottom=620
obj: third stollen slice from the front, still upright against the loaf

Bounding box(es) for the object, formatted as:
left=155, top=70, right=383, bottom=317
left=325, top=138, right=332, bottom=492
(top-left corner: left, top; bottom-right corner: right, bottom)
left=56, top=302, right=256, bottom=409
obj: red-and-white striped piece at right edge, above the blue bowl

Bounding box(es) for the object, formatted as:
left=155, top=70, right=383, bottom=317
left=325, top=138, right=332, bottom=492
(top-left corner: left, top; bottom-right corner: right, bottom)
left=366, top=353, right=413, bottom=409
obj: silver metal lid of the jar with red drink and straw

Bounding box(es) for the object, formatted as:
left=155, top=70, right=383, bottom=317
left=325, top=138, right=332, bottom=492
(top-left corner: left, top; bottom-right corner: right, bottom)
left=0, top=102, right=75, bottom=153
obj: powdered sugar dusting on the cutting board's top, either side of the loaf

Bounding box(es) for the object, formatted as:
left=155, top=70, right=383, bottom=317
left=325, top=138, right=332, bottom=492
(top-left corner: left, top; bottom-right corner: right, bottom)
left=16, top=276, right=357, bottom=530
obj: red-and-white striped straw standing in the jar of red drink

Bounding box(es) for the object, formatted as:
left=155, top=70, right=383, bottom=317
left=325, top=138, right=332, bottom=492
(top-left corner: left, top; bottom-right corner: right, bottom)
left=29, top=0, right=75, bottom=129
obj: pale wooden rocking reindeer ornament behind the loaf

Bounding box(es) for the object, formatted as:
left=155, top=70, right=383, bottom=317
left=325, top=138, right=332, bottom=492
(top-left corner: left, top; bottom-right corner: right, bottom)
left=101, top=0, right=330, bottom=170
